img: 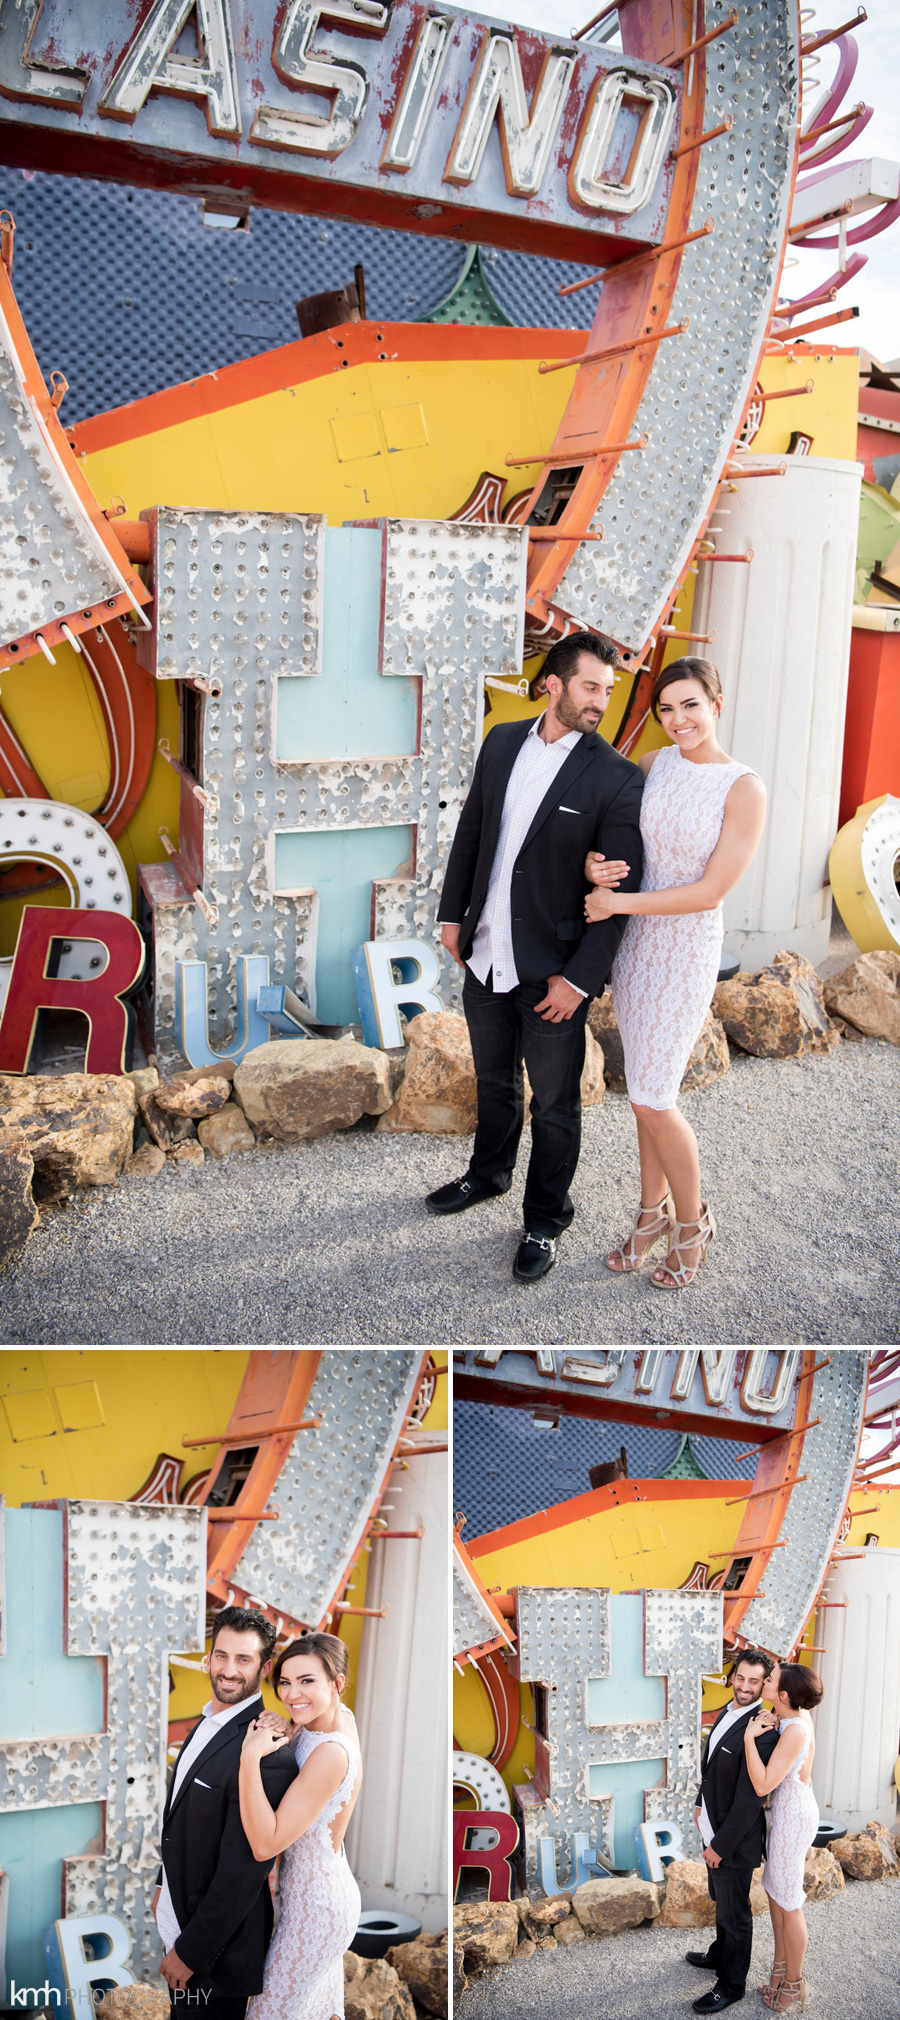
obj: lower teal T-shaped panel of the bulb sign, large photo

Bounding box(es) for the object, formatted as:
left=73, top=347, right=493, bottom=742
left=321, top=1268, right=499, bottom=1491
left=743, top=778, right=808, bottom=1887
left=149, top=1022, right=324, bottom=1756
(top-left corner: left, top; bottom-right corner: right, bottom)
left=274, top=826, right=414, bottom=1024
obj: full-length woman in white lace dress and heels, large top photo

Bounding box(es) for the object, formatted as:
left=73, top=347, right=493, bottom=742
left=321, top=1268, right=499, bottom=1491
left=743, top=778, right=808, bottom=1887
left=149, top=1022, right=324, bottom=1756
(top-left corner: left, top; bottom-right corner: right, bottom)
left=585, top=659, right=765, bottom=1291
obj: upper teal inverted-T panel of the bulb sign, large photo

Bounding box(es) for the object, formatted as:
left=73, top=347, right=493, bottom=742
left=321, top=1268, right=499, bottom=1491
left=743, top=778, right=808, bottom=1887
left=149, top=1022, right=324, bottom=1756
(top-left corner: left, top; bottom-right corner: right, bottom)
left=274, top=527, right=422, bottom=763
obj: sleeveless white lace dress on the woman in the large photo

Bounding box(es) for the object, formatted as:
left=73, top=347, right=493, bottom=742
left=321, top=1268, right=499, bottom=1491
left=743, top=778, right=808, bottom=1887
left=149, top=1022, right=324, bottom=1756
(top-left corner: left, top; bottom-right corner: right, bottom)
left=611, top=743, right=751, bottom=1109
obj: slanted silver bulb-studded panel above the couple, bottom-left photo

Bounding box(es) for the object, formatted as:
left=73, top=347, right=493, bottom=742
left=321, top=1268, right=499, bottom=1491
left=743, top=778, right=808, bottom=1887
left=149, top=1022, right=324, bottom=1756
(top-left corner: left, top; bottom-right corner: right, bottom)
left=234, top=1347, right=422, bottom=1626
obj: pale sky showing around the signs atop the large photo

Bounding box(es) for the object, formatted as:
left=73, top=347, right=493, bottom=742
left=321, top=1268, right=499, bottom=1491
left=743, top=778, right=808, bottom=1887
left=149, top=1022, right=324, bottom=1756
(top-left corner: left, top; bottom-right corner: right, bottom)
left=502, top=0, right=900, bottom=362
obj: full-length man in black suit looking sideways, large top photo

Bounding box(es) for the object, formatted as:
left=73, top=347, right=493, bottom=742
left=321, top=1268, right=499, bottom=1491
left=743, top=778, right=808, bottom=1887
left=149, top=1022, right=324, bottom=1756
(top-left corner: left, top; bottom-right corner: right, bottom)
left=426, top=632, right=644, bottom=1283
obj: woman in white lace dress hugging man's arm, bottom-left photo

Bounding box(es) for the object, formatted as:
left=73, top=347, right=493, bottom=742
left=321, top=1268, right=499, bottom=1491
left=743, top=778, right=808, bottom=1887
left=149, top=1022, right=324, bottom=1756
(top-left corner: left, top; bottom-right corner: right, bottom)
left=240, top=1634, right=361, bottom=2020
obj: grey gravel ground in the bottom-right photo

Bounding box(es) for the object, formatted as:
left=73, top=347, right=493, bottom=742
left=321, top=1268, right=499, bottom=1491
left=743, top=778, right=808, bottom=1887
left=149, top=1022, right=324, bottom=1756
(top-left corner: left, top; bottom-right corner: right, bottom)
left=456, top=1881, right=900, bottom=2020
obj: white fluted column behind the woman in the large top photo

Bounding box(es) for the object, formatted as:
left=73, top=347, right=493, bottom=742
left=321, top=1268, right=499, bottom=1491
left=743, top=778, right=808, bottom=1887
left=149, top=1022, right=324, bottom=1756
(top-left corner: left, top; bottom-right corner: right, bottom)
left=692, top=457, right=862, bottom=970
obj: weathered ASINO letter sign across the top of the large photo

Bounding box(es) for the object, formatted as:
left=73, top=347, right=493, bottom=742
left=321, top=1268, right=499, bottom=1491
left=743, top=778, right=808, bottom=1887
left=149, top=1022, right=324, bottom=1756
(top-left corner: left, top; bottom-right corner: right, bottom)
left=0, top=0, right=682, bottom=263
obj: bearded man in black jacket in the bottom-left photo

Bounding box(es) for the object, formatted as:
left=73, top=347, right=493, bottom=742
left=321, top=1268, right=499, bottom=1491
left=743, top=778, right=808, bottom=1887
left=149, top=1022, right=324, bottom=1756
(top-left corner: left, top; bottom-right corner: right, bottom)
left=153, top=1606, right=297, bottom=2020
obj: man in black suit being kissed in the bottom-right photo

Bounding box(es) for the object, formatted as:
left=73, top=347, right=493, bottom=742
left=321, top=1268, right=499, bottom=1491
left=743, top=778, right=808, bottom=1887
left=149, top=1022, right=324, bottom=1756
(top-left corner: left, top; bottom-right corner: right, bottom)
left=688, top=1648, right=779, bottom=2014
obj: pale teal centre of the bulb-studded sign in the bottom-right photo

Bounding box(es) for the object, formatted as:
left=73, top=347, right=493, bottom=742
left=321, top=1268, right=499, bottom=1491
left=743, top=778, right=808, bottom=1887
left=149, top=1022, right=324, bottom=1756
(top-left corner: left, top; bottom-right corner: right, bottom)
left=587, top=1592, right=666, bottom=1866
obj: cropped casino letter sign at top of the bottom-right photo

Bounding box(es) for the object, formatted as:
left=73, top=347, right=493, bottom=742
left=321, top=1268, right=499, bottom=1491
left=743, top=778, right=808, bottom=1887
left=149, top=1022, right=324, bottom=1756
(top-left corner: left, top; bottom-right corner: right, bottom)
left=454, top=1347, right=801, bottom=1438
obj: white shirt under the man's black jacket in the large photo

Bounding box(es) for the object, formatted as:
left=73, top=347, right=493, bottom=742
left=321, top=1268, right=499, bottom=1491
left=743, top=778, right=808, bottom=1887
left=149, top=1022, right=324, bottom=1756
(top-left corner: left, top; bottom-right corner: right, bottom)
left=466, top=715, right=585, bottom=996
